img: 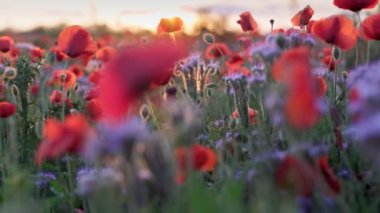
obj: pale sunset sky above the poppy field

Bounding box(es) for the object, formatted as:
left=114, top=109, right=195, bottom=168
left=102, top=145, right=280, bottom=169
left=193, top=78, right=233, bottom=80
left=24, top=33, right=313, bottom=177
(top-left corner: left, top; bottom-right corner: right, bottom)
left=0, top=0, right=356, bottom=31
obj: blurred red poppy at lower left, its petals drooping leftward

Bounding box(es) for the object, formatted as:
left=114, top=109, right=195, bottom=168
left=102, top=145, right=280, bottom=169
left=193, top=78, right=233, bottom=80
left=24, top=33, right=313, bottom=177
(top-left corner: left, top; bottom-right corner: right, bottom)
left=35, top=115, right=91, bottom=165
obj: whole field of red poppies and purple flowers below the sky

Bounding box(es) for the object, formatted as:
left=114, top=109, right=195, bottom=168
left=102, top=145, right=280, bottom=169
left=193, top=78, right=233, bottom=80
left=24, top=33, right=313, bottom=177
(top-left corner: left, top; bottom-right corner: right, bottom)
left=0, top=0, right=380, bottom=213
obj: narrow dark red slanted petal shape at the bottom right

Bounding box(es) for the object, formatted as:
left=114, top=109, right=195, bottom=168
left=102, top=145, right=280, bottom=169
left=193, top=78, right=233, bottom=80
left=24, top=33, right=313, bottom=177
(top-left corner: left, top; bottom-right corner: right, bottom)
left=318, top=156, right=340, bottom=194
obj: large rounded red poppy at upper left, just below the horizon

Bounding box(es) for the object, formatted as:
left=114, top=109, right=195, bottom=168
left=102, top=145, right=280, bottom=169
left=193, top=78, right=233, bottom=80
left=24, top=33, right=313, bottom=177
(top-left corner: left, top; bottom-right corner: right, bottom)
left=57, top=26, right=96, bottom=58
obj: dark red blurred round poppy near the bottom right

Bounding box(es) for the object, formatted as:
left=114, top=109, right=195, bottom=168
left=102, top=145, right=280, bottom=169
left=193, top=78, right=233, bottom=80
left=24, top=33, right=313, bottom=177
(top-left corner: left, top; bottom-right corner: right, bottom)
left=276, top=155, right=318, bottom=197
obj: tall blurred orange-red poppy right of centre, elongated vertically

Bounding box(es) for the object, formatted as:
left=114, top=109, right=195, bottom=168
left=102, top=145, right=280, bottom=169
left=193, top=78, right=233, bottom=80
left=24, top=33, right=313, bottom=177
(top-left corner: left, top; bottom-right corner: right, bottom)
left=273, top=47, right=321, bottom=129
